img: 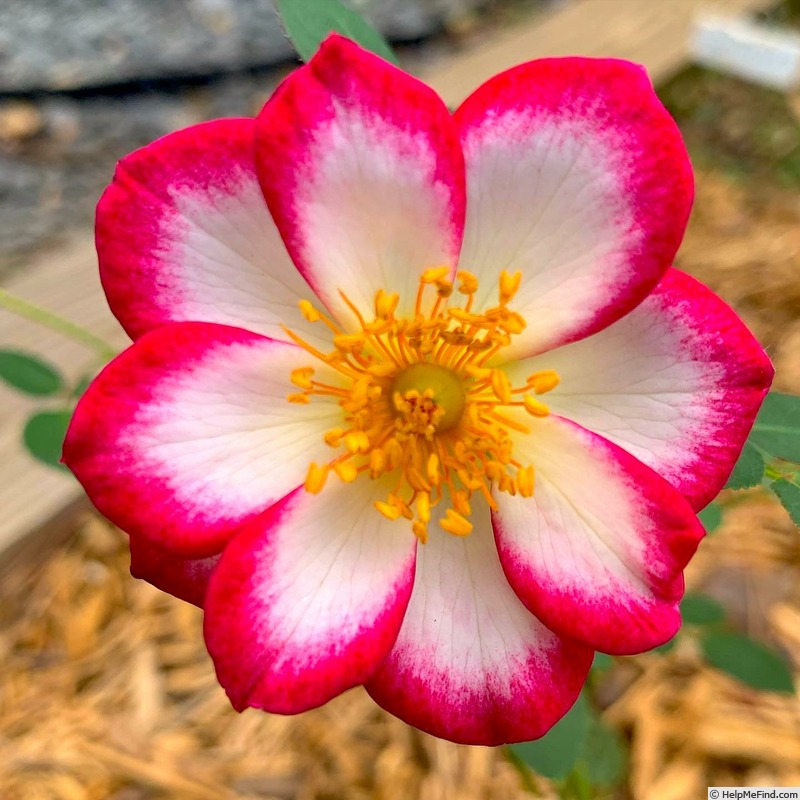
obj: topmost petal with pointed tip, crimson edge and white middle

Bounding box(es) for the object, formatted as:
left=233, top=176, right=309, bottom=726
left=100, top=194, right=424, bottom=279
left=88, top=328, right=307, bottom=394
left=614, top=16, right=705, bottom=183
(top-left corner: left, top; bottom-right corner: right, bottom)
left=256, top=35, right=465, bottom=323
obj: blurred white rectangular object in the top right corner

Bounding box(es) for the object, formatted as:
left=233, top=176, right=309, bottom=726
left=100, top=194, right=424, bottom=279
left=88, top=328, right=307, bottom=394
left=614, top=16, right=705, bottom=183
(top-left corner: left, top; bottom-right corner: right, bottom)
left=689, top=15, right=800, bottom=91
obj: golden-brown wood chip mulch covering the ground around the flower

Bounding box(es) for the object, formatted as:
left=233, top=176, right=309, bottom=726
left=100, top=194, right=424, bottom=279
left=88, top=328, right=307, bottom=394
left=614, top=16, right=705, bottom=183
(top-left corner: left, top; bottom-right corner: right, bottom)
left=0, top=167, right=800, bottom=800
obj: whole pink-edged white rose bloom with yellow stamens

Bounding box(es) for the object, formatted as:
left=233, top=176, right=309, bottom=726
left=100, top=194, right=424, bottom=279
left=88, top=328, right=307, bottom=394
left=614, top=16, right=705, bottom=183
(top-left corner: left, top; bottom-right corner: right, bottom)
left=64, top=36, right=772, bottom=744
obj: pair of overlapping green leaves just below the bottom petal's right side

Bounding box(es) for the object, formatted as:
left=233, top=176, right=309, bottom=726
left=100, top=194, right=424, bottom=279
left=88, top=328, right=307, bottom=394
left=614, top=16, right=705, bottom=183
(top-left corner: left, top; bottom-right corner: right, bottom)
left=509, top=692, right=625, bottom=797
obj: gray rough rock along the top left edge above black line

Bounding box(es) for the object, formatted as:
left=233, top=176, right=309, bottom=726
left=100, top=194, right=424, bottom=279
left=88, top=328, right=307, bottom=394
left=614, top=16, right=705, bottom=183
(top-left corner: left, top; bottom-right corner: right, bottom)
left=0, top=0, right=480, bottom=92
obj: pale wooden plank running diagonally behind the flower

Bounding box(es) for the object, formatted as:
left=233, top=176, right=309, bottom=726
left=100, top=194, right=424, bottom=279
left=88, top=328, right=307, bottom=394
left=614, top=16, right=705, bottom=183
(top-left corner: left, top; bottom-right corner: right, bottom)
left=0, top=0, right=780, bottom=551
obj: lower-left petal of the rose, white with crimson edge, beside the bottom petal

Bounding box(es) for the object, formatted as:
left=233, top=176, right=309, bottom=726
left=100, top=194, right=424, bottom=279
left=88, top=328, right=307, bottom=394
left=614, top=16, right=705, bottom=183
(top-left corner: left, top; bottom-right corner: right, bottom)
left=205, top=479, right=417, bottom=714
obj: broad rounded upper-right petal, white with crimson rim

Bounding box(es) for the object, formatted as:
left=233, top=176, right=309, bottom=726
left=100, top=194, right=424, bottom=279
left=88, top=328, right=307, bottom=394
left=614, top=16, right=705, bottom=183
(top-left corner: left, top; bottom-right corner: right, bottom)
left=455, top=58, right=694, bottom=358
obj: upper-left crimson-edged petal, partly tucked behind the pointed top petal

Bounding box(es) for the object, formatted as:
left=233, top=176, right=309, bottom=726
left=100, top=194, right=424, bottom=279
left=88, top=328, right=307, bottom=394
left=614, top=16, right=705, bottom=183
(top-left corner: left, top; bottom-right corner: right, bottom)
left=96, top=119, right=324, bottom=340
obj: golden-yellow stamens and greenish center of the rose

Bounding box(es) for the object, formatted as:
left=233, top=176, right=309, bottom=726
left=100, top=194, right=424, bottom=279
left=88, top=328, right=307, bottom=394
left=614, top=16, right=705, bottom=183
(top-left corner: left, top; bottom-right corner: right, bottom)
left=285, top=267, right=559, bottom=542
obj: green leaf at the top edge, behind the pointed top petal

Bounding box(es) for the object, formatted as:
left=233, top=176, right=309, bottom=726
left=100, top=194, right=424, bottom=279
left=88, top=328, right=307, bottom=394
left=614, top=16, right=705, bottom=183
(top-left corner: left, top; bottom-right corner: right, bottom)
left=277, top=0, right=397, bottom=64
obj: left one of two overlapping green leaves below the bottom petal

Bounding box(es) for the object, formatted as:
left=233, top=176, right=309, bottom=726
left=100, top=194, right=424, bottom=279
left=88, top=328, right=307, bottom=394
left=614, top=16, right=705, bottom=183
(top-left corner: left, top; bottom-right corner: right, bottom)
left=509, top=693, right=589, bottom=780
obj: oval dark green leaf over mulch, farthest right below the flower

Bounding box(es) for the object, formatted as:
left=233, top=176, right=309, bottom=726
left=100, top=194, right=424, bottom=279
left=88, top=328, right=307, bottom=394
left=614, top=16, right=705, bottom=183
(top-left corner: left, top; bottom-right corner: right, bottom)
left=703, top=631, right=794, bottom=693
